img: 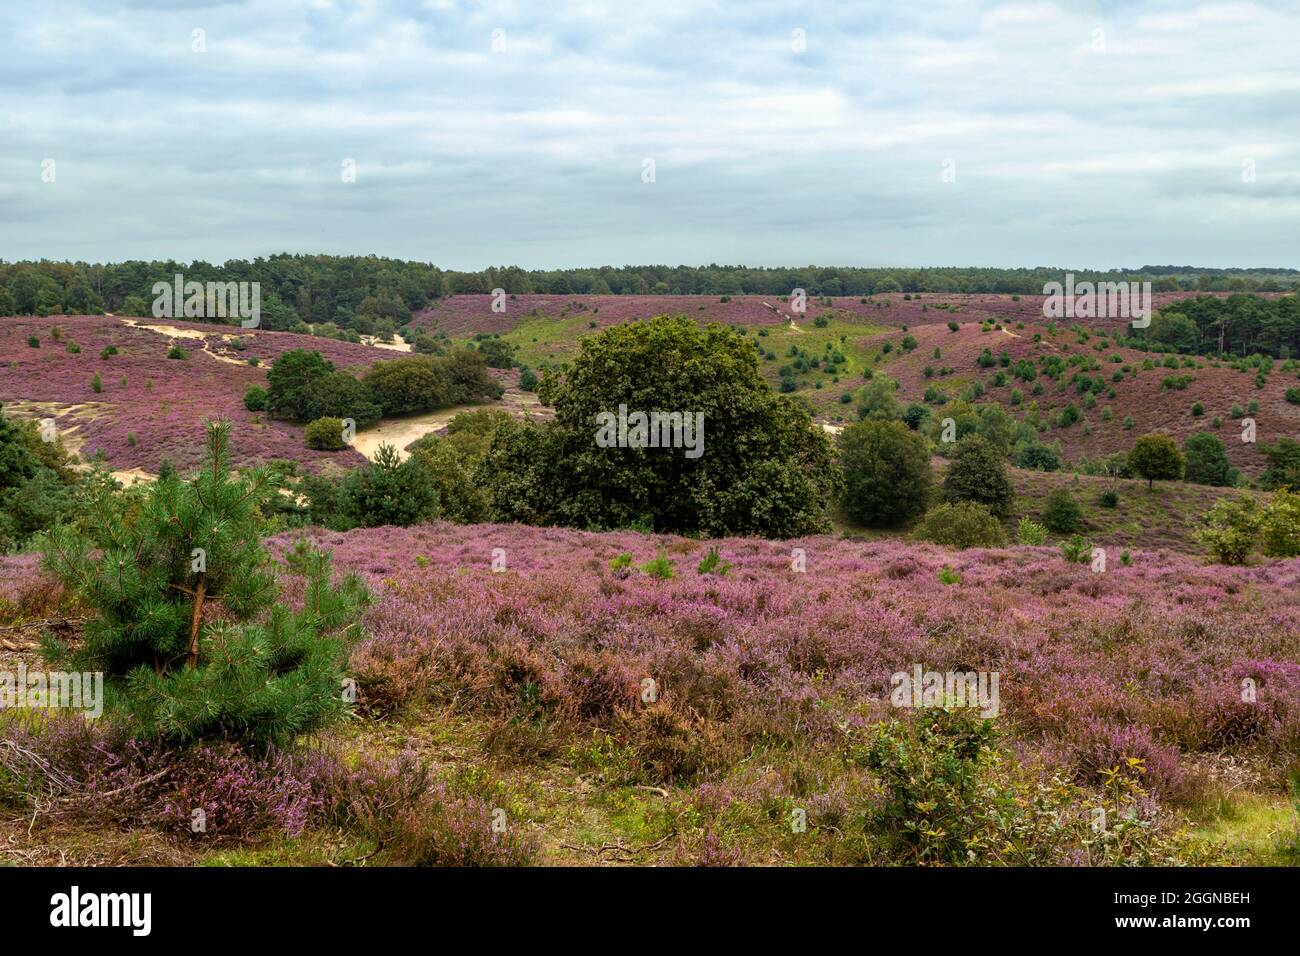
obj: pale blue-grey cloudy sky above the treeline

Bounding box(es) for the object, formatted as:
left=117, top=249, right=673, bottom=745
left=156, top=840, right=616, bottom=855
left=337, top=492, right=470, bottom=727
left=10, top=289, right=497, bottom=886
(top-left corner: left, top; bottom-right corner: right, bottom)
left=0, top=0, right=1300, bottom=269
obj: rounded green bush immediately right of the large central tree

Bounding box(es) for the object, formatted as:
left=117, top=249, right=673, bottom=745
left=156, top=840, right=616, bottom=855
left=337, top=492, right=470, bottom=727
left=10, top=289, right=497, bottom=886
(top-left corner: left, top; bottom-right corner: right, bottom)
left=840, top=419, right=931, bottom=527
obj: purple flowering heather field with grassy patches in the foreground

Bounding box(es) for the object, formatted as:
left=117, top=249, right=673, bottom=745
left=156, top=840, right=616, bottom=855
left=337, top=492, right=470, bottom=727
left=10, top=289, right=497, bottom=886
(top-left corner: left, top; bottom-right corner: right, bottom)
left=0, top=523, right=1300, bottom=865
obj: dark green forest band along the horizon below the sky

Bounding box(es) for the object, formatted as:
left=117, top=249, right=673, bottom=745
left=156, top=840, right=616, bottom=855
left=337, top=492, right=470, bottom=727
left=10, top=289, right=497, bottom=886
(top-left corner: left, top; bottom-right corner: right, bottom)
left=0, top=255, right=1300, bottom=332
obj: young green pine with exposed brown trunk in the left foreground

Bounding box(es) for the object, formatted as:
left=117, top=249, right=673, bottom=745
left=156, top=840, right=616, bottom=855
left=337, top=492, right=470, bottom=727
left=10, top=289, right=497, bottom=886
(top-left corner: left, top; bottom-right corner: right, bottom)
left=44, top=423, right=367, bottom=744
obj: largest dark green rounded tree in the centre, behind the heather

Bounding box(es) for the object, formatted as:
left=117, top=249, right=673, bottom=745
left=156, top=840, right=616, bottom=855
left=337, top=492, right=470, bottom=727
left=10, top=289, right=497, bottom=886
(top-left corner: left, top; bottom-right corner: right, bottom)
left=514, top=316, right=837, bottom=537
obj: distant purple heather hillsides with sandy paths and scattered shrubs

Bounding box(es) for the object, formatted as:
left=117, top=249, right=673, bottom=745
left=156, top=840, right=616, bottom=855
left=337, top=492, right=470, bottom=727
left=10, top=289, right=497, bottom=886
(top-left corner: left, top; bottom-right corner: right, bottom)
left=0, top=293, right=1300, bottom=489
